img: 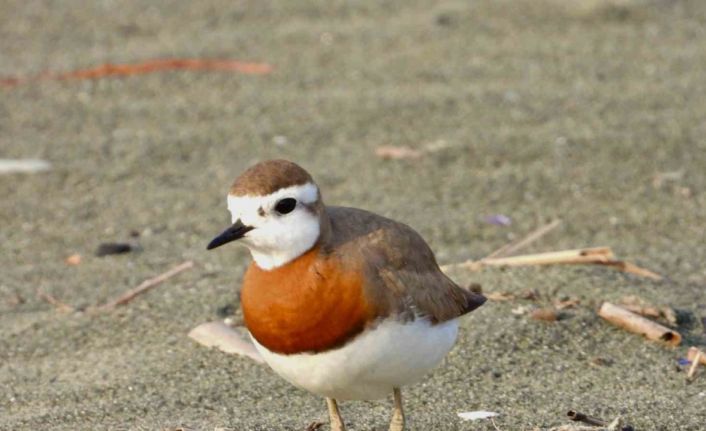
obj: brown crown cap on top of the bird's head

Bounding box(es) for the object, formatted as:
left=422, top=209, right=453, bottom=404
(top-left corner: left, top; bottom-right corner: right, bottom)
left=229, top=160, right=314, bottom=196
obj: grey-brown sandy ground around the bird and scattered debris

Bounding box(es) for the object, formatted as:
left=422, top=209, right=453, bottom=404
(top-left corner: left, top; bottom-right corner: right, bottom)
left=0, top=0, right=706, bottom=431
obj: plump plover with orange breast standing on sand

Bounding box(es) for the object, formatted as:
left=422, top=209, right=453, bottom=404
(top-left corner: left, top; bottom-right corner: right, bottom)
left=207, top=160, right=486, bottom=431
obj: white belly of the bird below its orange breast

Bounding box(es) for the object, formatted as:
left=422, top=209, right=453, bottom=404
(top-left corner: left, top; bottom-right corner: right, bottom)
left=253, top=318, right=458, bottom=400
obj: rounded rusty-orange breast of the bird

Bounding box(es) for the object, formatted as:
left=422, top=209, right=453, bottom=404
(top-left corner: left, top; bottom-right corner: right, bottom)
left=241, top=248, right=375, bottom=354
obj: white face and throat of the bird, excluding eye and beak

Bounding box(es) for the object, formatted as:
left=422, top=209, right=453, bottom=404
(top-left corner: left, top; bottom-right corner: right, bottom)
left=228, top=183, right=320, bottom=270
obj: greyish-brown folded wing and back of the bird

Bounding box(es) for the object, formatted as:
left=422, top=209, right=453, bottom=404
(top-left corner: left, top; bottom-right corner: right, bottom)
left=326, top=207, right=486, bottom=322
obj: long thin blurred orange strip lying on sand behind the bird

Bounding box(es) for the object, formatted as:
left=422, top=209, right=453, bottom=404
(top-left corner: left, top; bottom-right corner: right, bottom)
left=0, top=58, right=272, bottom=87
